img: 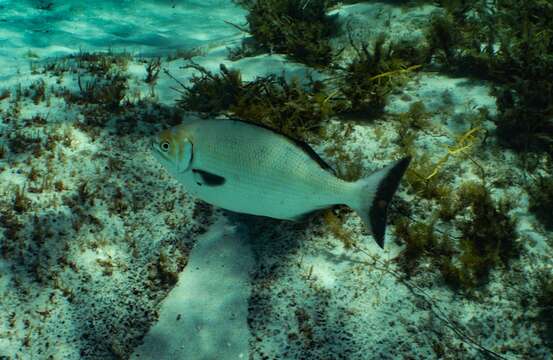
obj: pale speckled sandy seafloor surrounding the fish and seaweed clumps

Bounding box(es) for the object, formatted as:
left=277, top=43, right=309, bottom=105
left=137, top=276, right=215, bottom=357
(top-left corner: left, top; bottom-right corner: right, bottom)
left=0, top=0, right=553, bottom=359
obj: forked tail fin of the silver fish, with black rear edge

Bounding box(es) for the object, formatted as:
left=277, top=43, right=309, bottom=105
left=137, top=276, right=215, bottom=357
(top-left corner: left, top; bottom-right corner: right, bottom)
left=350, top=156, right=411, bottom=248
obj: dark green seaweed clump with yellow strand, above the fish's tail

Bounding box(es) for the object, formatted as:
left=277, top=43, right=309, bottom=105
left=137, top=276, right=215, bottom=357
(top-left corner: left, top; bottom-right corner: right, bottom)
left=339, top=33, right=420, bottom=117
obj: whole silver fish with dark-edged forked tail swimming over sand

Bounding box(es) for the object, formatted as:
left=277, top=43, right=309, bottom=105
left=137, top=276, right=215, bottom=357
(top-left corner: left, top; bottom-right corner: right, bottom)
left=151, top=119, right=411, bottom=247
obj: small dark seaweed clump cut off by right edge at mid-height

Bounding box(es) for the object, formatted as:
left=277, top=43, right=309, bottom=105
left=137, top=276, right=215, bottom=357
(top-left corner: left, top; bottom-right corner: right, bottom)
left=528, top=176, right=553, bottom=231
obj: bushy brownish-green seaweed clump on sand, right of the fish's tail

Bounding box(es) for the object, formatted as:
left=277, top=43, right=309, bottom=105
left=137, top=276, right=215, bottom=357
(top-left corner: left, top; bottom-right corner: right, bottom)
left=394, top=182, right=521, bottom=292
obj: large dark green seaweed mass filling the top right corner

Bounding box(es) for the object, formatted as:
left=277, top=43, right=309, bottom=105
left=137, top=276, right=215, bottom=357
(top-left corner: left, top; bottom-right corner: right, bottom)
left=427, top=0, right=553, bottom=154
